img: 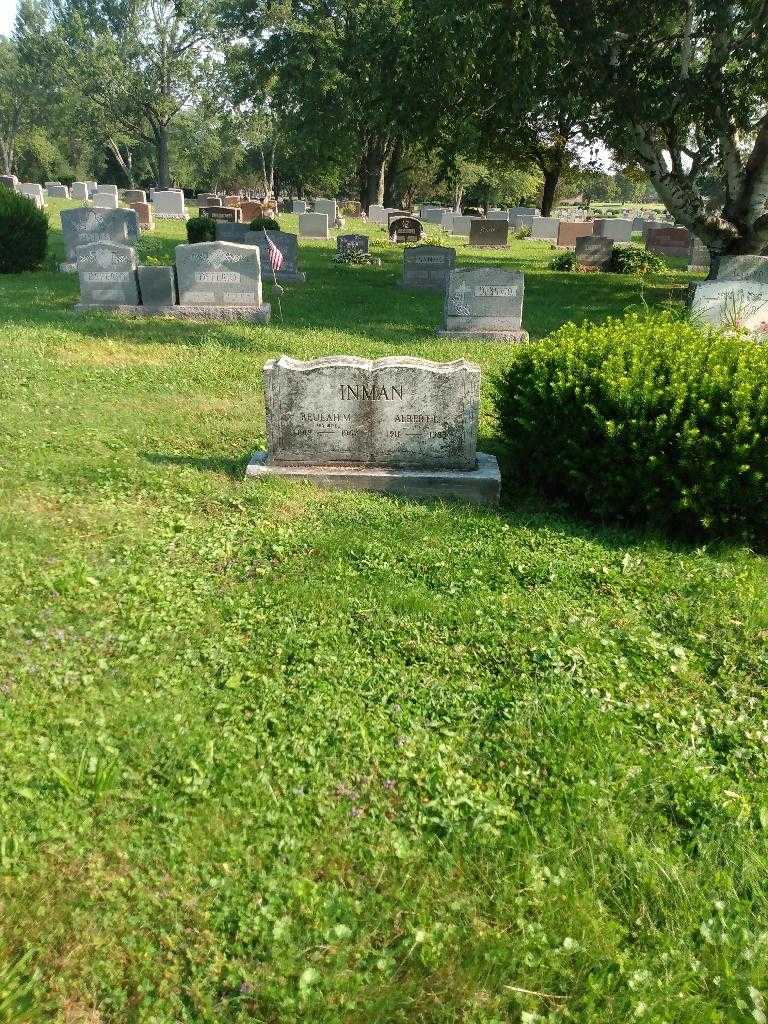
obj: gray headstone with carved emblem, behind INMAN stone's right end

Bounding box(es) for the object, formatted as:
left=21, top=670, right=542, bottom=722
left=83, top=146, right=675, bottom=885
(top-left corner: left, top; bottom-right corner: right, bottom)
left=438, top=267, right=527, bottom=341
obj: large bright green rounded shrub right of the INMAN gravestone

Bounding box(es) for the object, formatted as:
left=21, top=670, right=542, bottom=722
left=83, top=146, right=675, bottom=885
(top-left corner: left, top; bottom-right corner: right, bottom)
left=496, top=313, right=768, bottom=545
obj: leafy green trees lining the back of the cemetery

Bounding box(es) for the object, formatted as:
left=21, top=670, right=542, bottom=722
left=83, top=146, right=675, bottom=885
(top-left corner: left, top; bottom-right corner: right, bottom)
left=0, top=0, right=768, bottom=260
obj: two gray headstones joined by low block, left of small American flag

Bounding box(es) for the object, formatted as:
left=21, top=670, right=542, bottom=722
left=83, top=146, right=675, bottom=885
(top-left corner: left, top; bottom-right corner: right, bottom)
left=75, top=241, right=262, bottom=309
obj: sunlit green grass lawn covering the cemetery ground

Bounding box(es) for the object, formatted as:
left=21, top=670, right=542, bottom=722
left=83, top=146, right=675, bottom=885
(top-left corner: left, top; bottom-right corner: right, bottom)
left=0, top=203, right=768, bottom=1024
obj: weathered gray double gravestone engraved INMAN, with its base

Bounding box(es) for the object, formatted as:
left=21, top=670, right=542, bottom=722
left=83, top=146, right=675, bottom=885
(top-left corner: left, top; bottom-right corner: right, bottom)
left=246, top=355, right=500, bottom=504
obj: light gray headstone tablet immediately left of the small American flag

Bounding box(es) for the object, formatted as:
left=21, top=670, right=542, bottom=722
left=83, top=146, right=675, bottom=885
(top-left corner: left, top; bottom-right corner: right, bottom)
left=176, top=242, right=261, bottom=306
